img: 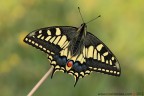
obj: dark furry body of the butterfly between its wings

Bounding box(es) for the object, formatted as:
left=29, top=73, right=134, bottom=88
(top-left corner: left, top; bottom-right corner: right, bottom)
left=68, top=23, right=86, bottom=56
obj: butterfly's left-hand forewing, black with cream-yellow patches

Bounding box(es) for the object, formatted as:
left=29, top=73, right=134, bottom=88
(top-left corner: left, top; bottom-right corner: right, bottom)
left=24, top=26, right=76, bottom=54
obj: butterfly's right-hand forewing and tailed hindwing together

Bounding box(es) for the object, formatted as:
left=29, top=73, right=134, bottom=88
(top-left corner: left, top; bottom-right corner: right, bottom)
left=63, top=32, right=121, bottom=86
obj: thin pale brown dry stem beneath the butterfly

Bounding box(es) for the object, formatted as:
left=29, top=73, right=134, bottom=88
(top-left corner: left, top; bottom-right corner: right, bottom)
left=27, top=66, right=53, bottom=96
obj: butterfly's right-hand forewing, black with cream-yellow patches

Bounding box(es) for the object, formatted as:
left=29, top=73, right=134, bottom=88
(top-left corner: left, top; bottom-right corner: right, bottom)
left=84, top=32, right=121, bottom=76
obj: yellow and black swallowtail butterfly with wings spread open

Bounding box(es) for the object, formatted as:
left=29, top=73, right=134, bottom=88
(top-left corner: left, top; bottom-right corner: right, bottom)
left=24, top=10, right=121, bottom=86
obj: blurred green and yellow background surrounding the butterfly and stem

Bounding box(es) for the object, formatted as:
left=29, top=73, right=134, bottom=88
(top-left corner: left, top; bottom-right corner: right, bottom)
left=0, top=0, right=144, bottom=96
